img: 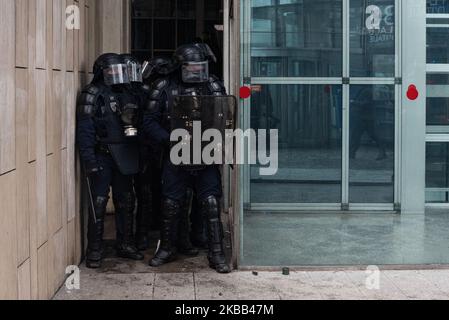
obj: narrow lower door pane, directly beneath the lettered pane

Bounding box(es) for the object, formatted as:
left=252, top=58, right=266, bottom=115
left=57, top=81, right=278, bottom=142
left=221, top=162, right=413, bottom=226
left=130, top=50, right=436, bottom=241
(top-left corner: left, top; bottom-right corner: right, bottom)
left=349, top=85, right=395, bottom=203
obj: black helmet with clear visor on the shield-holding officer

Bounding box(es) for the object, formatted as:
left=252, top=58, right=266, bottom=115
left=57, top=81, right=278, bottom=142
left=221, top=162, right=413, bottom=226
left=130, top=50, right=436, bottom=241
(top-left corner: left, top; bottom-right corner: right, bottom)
left=174, top=43, right=216, bottom=83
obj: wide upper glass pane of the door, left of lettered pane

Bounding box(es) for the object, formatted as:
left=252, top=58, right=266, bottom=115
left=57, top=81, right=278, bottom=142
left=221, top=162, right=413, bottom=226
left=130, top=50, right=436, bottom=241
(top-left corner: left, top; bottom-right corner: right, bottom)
left=251, top=0, right=343, bottom=77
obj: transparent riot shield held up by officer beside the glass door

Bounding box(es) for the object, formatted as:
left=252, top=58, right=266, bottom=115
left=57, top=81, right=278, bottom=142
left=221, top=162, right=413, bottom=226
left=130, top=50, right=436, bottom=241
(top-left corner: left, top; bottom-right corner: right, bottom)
left=170, top=96, right=237, bottom=167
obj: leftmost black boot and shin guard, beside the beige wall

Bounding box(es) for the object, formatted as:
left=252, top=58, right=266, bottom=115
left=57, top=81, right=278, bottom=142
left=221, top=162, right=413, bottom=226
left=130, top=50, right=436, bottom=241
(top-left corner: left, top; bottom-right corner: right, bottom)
left=86, top=197, right=109, bottom=269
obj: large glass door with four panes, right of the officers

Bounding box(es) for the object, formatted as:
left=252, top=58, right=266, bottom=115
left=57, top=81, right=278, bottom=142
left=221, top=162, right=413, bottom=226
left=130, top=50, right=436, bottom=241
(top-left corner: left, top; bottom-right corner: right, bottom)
left=241, top=0, right=401, bottom=211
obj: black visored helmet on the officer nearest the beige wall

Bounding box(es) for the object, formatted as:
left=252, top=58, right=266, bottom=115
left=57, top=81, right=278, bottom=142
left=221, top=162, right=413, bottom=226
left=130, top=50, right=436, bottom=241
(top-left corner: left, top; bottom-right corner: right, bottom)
left=93, top=53, right=130, bottom=86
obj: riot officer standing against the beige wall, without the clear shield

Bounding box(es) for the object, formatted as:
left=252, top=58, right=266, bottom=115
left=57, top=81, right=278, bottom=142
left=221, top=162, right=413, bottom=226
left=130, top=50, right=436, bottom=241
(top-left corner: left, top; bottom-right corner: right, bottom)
left=77, top=53, right=144, bottom=268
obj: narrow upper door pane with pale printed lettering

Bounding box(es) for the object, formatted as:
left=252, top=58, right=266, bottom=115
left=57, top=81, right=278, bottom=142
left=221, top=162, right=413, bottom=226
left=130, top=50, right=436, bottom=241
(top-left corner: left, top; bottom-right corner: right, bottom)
left=350, top=0, right=395, bottom=77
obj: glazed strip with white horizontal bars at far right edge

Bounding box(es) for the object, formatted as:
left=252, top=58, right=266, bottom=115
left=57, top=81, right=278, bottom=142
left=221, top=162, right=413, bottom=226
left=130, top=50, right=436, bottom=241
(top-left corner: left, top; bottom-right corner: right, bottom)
left=426, top=0, right=449, bottom=208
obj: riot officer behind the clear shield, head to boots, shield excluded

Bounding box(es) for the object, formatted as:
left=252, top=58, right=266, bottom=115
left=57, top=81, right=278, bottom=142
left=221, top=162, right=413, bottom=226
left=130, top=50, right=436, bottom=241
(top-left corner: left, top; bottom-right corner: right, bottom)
left=144, top=44, right=230, bottom=273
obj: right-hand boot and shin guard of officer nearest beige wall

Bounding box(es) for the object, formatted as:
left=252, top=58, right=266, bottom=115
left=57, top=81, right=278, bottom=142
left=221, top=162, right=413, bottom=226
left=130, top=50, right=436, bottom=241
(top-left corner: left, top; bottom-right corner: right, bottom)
left=114, top=193, right=144, bottom=260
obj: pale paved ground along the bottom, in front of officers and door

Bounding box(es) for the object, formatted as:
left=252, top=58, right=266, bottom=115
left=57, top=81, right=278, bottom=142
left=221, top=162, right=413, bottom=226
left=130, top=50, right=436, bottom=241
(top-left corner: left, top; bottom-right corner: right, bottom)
left=54, top=256, right=449, bottom=300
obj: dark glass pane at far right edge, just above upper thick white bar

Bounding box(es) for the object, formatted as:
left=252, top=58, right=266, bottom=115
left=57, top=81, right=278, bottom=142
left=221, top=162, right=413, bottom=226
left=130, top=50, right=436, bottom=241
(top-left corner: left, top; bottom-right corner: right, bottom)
left=427, top=28, right=449, bottom=63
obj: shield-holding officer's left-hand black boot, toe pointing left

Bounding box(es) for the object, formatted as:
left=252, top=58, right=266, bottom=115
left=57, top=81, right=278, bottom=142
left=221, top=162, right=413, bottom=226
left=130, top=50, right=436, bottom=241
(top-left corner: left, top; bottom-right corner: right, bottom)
left=150, top=199, right=181, bottom=267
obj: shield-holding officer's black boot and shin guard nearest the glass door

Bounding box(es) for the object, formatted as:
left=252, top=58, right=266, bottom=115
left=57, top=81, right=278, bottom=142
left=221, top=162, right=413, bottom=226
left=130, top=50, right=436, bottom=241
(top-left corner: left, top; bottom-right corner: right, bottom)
left=201, top=196, right=231, bottom=273
